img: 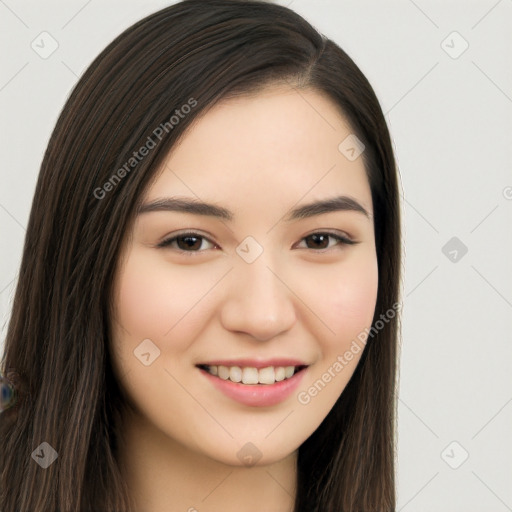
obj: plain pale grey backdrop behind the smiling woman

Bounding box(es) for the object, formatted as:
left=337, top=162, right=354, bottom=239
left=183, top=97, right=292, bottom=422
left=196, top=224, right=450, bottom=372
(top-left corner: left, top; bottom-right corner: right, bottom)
left=0, top=0, right=512, bottom=512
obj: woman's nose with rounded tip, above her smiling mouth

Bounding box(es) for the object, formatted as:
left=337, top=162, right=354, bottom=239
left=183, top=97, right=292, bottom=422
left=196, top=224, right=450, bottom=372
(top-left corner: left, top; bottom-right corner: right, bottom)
left=221, top=256, right=296, bottom=341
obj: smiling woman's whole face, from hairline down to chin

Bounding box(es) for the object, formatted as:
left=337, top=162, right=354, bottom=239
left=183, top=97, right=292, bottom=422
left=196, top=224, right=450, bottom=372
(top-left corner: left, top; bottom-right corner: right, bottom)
left=112, top=87, right=378, bottom=465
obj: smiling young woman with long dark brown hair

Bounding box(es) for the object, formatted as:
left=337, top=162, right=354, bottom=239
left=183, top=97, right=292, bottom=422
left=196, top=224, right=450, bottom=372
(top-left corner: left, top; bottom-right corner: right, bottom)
left=0, top=0, right=401, bottom=512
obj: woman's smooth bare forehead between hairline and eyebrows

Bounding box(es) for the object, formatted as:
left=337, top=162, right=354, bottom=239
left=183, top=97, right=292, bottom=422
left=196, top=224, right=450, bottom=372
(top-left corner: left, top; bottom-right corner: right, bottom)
left=146, top=87, right=372, bottom=215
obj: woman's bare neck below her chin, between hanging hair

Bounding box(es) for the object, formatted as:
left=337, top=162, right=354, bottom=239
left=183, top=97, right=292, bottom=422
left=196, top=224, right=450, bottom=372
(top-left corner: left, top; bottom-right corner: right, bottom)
left=119, top=406, right=297, bottom=512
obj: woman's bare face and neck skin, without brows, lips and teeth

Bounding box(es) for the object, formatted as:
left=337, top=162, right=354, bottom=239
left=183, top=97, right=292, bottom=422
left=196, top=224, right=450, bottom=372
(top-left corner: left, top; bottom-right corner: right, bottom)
left=112, top=86, right=378, bottom=512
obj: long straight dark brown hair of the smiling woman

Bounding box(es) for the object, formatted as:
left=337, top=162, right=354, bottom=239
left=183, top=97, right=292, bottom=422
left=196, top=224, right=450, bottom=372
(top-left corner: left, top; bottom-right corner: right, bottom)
left=0, top=0, right=401, bottom=512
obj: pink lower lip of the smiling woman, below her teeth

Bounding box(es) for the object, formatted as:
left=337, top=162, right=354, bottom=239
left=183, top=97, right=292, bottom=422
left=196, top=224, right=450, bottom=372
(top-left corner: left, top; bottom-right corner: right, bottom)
left=199, top=368, right=308, bottom=407
